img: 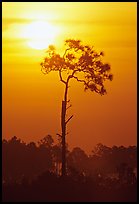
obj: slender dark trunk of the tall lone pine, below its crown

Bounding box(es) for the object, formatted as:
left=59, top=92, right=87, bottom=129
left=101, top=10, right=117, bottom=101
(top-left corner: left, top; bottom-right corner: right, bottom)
left=61, top=82, right=68, bottom=176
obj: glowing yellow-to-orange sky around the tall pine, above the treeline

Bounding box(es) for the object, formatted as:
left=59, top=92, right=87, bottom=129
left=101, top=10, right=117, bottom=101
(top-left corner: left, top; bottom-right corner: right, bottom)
left=2, top=2, right=137, bottom=151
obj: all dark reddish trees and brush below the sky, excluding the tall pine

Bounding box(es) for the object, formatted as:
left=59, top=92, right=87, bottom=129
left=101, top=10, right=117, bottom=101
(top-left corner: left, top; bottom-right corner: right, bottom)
left=2, top=135, right=137, bottom=202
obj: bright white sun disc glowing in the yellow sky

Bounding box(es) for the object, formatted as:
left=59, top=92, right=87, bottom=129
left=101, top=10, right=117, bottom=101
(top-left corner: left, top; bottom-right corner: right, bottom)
left=22, top=21, right=59, bottom=50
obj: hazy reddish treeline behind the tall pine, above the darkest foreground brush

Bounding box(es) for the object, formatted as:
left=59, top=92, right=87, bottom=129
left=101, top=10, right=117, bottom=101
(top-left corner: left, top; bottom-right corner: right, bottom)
left=2, top=135, right=137, bottom=183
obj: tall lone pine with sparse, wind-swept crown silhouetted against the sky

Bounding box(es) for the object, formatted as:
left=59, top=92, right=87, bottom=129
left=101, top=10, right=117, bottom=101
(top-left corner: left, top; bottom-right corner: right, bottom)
left=41, top=39, right=113, bottom=176
